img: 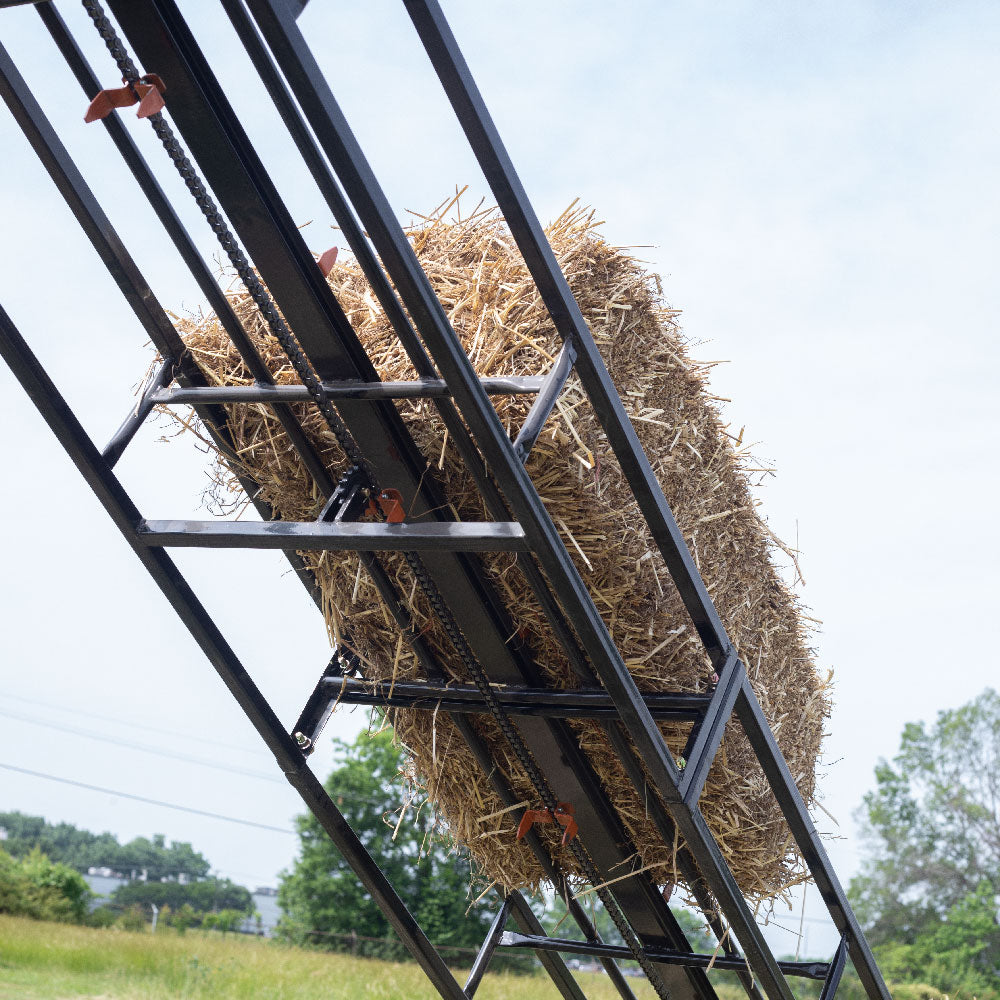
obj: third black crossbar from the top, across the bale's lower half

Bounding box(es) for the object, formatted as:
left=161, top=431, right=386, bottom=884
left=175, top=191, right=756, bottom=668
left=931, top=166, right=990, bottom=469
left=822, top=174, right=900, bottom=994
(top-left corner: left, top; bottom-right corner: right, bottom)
left=330, top=677, right=711, bottom=721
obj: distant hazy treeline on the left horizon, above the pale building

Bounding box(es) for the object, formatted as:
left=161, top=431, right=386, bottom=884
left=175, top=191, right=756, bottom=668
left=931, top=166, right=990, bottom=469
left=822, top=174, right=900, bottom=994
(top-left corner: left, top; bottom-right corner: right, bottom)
left=0, top=812, right=211, bottom=881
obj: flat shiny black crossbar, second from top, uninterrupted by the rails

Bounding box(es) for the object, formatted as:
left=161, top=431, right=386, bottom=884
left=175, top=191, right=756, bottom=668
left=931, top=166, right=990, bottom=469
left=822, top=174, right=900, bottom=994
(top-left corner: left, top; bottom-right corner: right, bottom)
left=136, top=520, right=528, bottom=552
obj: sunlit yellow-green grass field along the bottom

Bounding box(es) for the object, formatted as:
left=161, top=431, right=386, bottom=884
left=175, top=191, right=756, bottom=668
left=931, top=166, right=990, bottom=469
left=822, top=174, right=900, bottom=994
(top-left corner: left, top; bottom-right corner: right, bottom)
left=0, top=915, right=672, bottom=1000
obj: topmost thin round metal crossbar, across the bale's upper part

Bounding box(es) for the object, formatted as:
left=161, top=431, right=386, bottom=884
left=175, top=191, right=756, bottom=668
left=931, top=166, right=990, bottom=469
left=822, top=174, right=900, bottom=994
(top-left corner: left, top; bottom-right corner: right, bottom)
left=153, top=375, right=545, bottom=406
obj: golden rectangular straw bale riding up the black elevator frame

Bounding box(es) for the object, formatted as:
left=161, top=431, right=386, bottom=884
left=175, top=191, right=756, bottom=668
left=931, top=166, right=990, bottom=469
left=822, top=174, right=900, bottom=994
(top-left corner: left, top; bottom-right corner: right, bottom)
left=170, top=199, right=829, bottom=899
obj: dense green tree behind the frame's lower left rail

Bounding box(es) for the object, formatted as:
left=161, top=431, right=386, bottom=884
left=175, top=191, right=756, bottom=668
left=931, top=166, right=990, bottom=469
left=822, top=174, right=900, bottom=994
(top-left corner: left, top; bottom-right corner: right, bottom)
left=278, top=730, right=493, bottom=956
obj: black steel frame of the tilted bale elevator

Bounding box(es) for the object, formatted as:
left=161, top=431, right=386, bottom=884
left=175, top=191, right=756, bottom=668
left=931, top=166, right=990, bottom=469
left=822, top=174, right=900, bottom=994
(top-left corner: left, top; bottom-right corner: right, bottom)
left=0, top=0, right=889, bottom=1000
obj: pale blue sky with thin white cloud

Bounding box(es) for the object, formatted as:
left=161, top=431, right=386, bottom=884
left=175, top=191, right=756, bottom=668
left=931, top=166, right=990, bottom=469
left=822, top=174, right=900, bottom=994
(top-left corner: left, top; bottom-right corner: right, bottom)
left=0, top=0, right=1000, bottom=968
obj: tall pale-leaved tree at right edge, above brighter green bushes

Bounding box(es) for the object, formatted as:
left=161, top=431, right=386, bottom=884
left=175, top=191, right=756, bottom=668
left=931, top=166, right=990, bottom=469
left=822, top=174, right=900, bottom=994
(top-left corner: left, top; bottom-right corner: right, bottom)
left=851, top=689, right=1000, bottom=945
